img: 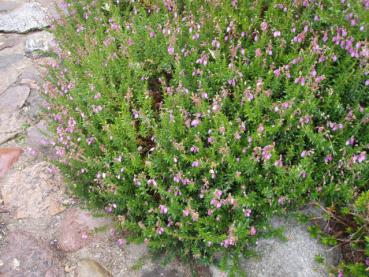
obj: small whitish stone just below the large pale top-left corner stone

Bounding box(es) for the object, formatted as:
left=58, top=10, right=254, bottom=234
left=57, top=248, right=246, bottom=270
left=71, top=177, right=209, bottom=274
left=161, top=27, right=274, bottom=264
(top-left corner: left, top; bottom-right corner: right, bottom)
left=24, top=31, right=55, bottom=57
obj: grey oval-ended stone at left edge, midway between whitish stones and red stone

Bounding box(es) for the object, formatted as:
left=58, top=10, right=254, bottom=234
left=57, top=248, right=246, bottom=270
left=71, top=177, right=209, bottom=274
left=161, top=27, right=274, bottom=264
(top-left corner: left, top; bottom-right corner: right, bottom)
left=0, top=86, right=30, bottom=113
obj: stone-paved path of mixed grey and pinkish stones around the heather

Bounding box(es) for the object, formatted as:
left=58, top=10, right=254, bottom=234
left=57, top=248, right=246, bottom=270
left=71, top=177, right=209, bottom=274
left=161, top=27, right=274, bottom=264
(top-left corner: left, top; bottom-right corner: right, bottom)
left=0, top=0, right=337, bottom=277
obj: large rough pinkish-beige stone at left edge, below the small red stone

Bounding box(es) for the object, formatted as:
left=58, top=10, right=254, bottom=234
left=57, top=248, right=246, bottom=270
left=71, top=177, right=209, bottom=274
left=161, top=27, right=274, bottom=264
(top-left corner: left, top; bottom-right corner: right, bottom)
left=0, top=162, right=65, bottom=219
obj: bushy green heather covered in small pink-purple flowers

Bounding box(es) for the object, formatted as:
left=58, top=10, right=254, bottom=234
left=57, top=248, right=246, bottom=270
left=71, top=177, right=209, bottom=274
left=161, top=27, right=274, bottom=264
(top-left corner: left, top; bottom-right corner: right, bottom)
left=47, top=0, right=369, bottom=276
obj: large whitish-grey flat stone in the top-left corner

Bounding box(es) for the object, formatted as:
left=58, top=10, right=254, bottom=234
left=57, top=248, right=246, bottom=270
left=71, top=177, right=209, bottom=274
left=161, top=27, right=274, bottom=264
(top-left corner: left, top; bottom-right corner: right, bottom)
left=0, top=2, right=49, bottom=33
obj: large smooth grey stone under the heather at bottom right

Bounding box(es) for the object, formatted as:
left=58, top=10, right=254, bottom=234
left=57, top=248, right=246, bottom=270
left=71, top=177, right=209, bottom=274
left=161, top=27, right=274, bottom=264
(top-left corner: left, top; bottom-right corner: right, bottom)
left=239, top=218, right=339, bottom=277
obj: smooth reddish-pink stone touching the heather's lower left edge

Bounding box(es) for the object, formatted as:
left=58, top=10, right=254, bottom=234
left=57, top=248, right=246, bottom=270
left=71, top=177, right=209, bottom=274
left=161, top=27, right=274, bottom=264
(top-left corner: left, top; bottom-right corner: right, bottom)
left=57, top=209, right=111, bottom=252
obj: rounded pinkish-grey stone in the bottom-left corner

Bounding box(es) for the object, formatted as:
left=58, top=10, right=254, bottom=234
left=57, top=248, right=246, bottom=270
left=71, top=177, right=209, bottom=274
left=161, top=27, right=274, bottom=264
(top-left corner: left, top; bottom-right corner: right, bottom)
left=0, top=231, right=64, bottom=277
